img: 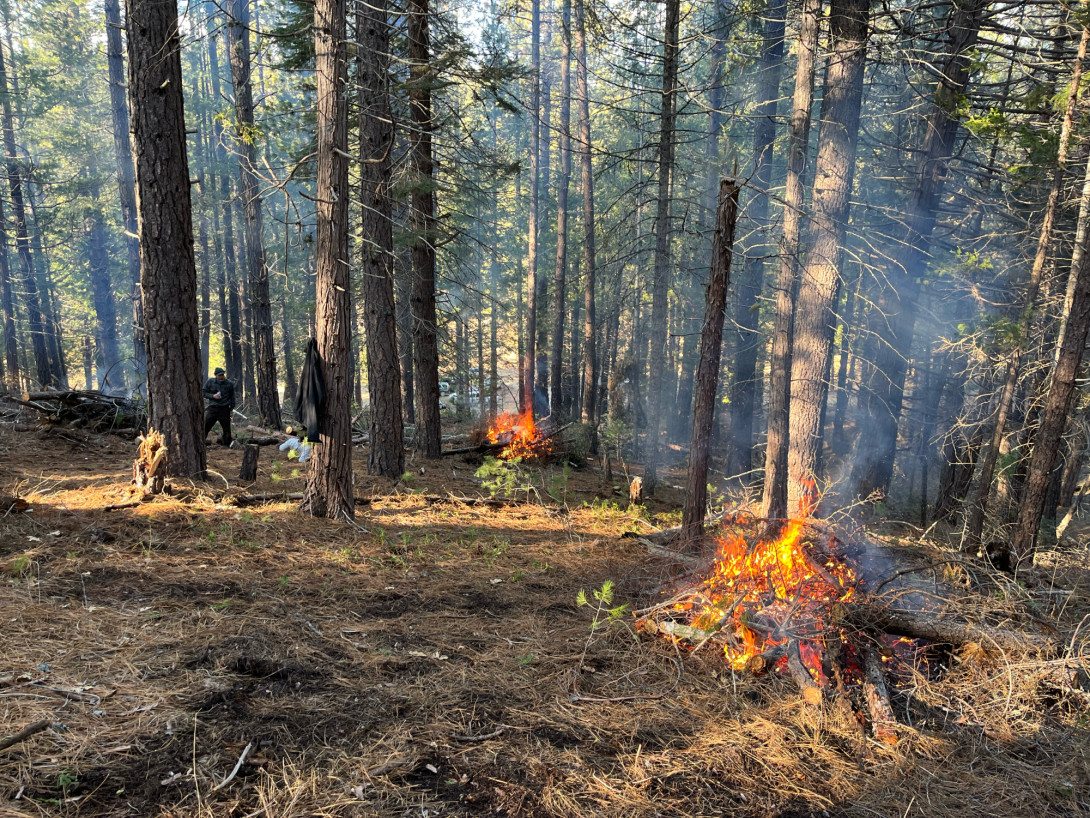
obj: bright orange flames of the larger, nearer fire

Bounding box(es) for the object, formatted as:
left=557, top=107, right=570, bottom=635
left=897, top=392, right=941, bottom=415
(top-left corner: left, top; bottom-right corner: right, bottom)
left=694, top=483, right=855, bottom=673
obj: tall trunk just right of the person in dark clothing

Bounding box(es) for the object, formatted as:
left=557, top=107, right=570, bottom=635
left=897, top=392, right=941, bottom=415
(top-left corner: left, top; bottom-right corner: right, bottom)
left=227, top=0, right=281, bottom=429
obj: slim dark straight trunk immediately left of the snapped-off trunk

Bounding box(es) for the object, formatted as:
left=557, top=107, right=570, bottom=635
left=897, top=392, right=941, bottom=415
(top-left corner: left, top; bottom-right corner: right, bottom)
left=640, top=0, right=681, bottom=495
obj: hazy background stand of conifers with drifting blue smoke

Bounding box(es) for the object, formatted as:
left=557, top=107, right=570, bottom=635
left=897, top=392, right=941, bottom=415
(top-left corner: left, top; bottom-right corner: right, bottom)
left=0, top=0, right=1090, bottom=558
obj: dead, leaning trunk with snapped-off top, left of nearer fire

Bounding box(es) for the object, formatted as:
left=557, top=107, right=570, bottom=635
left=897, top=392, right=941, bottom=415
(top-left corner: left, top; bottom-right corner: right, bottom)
left=681, top=179, right=738, bottom=544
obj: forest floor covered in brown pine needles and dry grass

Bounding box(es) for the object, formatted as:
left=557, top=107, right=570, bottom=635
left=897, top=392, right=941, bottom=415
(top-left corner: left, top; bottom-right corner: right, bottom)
left=0, top=418, right=1090, bottom=818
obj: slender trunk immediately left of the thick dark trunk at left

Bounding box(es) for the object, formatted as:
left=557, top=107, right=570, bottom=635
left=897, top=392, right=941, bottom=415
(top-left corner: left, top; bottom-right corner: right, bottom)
left=104, top=0, right=147, bottom=384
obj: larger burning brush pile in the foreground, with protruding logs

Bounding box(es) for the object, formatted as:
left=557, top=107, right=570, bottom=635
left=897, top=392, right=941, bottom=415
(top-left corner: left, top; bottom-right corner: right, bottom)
left=638, top=499, right=1054, bottom=743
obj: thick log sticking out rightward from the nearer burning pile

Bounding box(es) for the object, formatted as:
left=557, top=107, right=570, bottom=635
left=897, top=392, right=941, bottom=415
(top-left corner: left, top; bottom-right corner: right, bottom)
left=841, top=602, right=1057, bottom=653
